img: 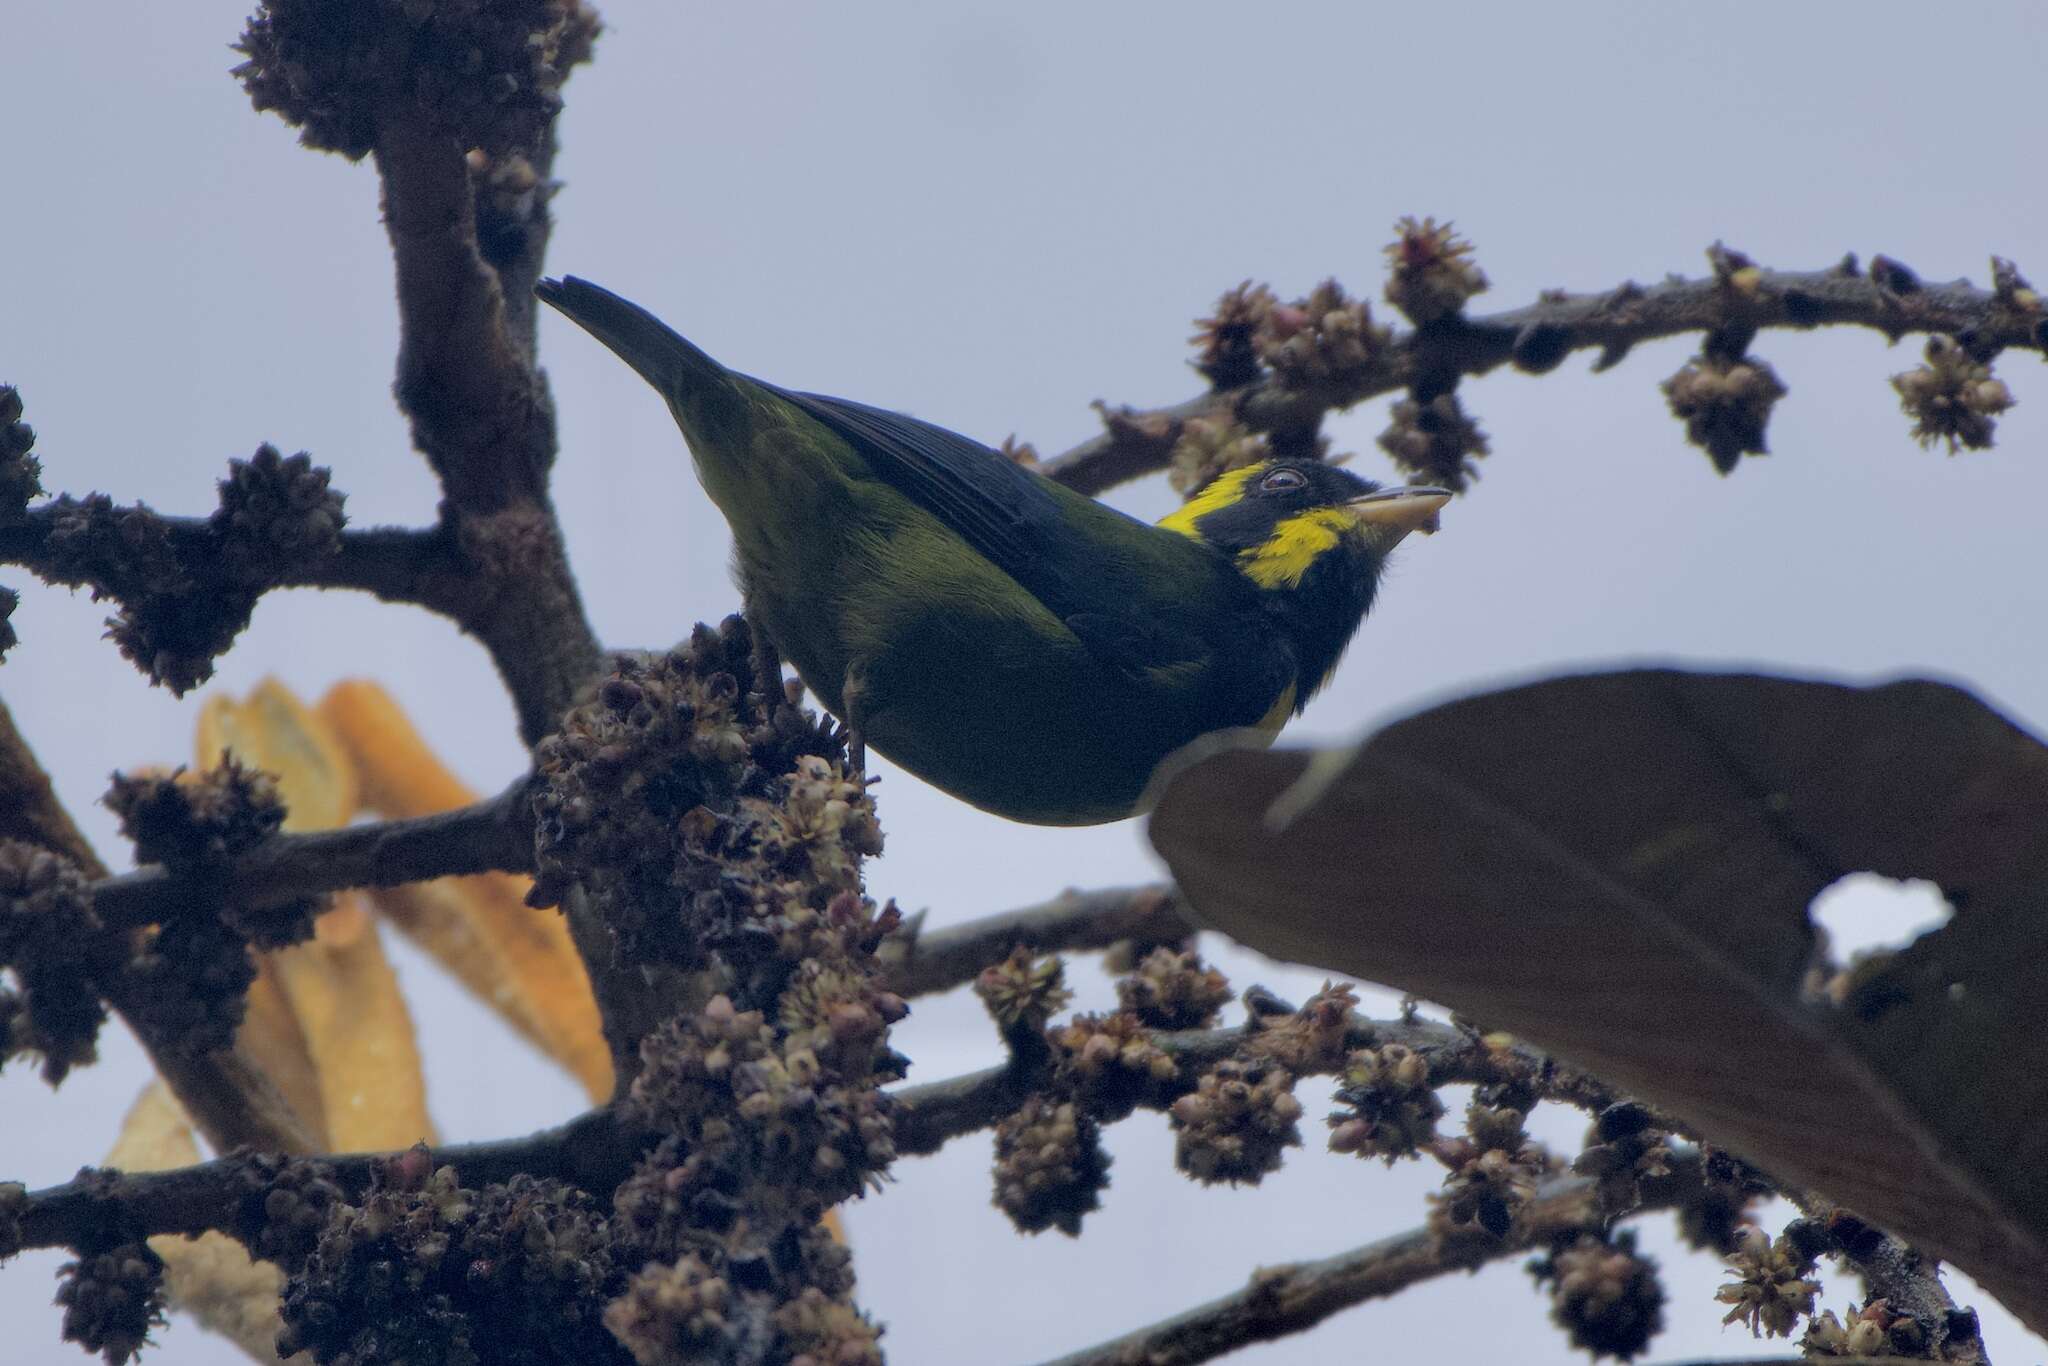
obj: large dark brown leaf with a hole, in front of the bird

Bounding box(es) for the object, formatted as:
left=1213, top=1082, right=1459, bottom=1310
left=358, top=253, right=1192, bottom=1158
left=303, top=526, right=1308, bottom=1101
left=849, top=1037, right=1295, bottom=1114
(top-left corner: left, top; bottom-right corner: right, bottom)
left=1151, top=672, right=2048, bottom=1331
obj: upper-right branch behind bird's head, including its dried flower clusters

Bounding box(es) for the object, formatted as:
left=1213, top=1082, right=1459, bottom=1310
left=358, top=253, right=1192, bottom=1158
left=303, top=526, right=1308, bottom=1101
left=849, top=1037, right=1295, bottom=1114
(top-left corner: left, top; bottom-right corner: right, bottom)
left=1040, top=248, right=2048, bottom=494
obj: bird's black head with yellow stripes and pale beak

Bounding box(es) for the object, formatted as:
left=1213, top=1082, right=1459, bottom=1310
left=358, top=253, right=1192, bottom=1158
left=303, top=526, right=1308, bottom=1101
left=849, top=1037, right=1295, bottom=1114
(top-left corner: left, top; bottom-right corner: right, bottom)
left=1159, top=459, right=1450, bottom=711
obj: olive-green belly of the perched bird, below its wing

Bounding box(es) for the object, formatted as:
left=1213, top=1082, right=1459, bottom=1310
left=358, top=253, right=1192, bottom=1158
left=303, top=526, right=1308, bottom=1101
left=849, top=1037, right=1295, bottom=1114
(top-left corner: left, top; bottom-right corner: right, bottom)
left=735, top=497, right=1292, bottom=825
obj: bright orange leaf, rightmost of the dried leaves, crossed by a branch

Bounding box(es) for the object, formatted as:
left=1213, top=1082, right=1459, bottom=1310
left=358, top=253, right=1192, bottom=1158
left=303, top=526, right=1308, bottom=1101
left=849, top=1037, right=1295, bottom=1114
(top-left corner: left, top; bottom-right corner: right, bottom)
left=319, top=680, right=612, bottom=1102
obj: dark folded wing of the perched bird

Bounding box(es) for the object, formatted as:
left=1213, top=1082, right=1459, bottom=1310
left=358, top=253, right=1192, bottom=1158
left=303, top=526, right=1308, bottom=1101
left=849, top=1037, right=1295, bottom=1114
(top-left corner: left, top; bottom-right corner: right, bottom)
left=756, top=381, right=1212, bottom=682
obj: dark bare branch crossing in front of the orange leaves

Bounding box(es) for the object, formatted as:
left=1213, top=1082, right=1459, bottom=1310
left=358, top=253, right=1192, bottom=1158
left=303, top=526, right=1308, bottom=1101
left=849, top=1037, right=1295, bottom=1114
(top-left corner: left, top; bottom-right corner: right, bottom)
left=92, top=778, right=532, bottom=928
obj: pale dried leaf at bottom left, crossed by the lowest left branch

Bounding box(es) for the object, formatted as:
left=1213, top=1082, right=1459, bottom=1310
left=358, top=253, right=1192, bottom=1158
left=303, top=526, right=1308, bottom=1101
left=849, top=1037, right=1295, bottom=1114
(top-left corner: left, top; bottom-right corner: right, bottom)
left=106, top=1079, right=305, bottom=1362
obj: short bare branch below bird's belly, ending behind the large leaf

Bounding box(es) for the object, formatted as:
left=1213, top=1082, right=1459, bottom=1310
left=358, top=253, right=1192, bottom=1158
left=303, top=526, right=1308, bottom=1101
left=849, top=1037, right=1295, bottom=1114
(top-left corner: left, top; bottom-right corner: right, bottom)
left=879, top=883, right=1194, bottom=997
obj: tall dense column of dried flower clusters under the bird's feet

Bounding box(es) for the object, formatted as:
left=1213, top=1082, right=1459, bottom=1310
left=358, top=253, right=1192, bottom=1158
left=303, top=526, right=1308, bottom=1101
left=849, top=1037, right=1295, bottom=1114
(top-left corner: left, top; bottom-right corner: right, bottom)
left=535, top=618, right=907, bottom=1360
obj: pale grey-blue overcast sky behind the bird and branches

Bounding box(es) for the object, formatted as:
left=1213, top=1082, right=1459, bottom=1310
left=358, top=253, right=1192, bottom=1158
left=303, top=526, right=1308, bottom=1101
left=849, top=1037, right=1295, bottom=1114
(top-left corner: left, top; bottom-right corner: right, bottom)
left=0, top=0, right=2048, bottom=1366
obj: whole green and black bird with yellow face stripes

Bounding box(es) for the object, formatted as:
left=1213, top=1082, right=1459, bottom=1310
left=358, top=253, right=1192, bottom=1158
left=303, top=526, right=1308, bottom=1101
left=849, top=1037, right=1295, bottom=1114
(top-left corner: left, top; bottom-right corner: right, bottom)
left=539, top=276, right=1450, bottom=825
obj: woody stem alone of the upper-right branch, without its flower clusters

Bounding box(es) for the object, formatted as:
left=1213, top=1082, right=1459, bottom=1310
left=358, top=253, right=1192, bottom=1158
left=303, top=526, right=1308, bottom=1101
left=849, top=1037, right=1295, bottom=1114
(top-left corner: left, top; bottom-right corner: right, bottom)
left=1040, top=256, right=2048, bottom=494
